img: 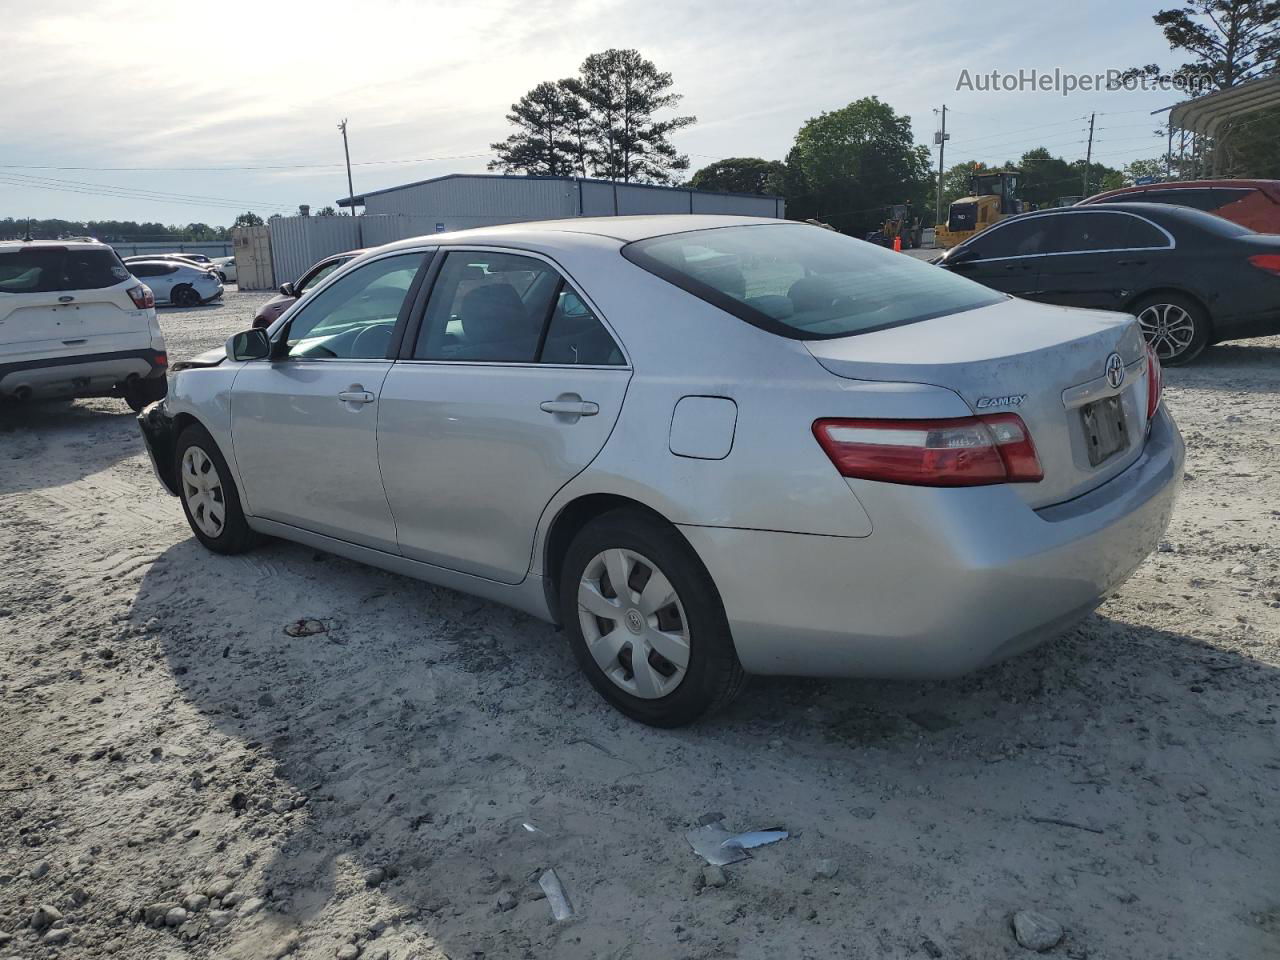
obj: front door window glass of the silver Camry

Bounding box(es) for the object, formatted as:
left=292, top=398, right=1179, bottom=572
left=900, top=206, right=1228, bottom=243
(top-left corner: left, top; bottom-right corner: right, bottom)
left=285, top=253, right=422, bottom=360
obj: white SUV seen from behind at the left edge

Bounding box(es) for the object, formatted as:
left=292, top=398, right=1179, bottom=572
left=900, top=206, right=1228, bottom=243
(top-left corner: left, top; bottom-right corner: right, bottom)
left=0, top=239, right=169, bottom=410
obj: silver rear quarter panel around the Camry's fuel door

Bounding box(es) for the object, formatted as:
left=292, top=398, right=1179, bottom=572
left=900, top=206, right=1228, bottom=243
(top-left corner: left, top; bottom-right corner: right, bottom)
left=524, top=238, right=970, bottom=572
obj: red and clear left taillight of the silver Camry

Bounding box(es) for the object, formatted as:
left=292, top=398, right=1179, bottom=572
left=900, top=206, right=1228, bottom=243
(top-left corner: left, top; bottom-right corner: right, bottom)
left=813, top=413, right=1044, bottom=486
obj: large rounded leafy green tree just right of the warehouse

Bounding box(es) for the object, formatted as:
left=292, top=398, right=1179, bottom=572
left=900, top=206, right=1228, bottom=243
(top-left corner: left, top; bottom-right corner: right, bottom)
left=787, top=96, right=933, bottom=236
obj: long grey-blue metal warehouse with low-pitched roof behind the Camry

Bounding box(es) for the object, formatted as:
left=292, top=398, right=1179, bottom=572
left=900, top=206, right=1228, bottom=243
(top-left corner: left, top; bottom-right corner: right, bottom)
left=338, top=174, right=786, bottom=233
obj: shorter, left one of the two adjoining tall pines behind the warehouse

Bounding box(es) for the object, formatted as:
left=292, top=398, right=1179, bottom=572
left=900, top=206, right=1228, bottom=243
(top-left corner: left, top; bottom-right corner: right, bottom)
left=489, top=81, right=586, bottom=177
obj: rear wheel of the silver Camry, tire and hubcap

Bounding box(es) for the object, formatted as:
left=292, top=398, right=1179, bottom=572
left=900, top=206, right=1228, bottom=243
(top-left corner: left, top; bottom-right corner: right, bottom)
left=559, top=509, right=746, bottom=727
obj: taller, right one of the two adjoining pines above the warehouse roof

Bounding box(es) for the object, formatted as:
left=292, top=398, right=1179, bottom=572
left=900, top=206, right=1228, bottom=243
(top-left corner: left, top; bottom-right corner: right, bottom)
left=561, top=49, right=696, bottom=183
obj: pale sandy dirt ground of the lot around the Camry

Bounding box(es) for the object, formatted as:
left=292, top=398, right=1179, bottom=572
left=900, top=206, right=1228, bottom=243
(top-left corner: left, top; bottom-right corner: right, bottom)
left=0, top=292, right=1280, bottom=960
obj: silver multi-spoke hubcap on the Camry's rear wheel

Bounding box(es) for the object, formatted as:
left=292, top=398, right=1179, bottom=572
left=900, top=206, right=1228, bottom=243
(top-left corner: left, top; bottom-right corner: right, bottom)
left=577, top=548, right=689, bottom=700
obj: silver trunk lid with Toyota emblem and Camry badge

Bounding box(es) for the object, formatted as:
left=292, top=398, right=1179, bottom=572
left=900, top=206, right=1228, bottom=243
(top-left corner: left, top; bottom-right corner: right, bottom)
left=805, top=298, right=1147, bottom=507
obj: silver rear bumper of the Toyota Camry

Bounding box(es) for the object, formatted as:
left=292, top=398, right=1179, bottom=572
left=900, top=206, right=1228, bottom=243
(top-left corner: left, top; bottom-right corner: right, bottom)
left=681, top=410, right=1184, bottom=677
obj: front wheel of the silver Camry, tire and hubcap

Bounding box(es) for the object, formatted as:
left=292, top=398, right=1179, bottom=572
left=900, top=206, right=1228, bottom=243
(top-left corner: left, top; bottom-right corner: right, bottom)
left=174, top=424, right=259, bottom=553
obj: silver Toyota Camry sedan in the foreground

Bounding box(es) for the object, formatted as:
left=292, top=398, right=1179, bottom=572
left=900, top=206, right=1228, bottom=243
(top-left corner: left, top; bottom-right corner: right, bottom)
left=141, top=215, right=1183, bottom=726
